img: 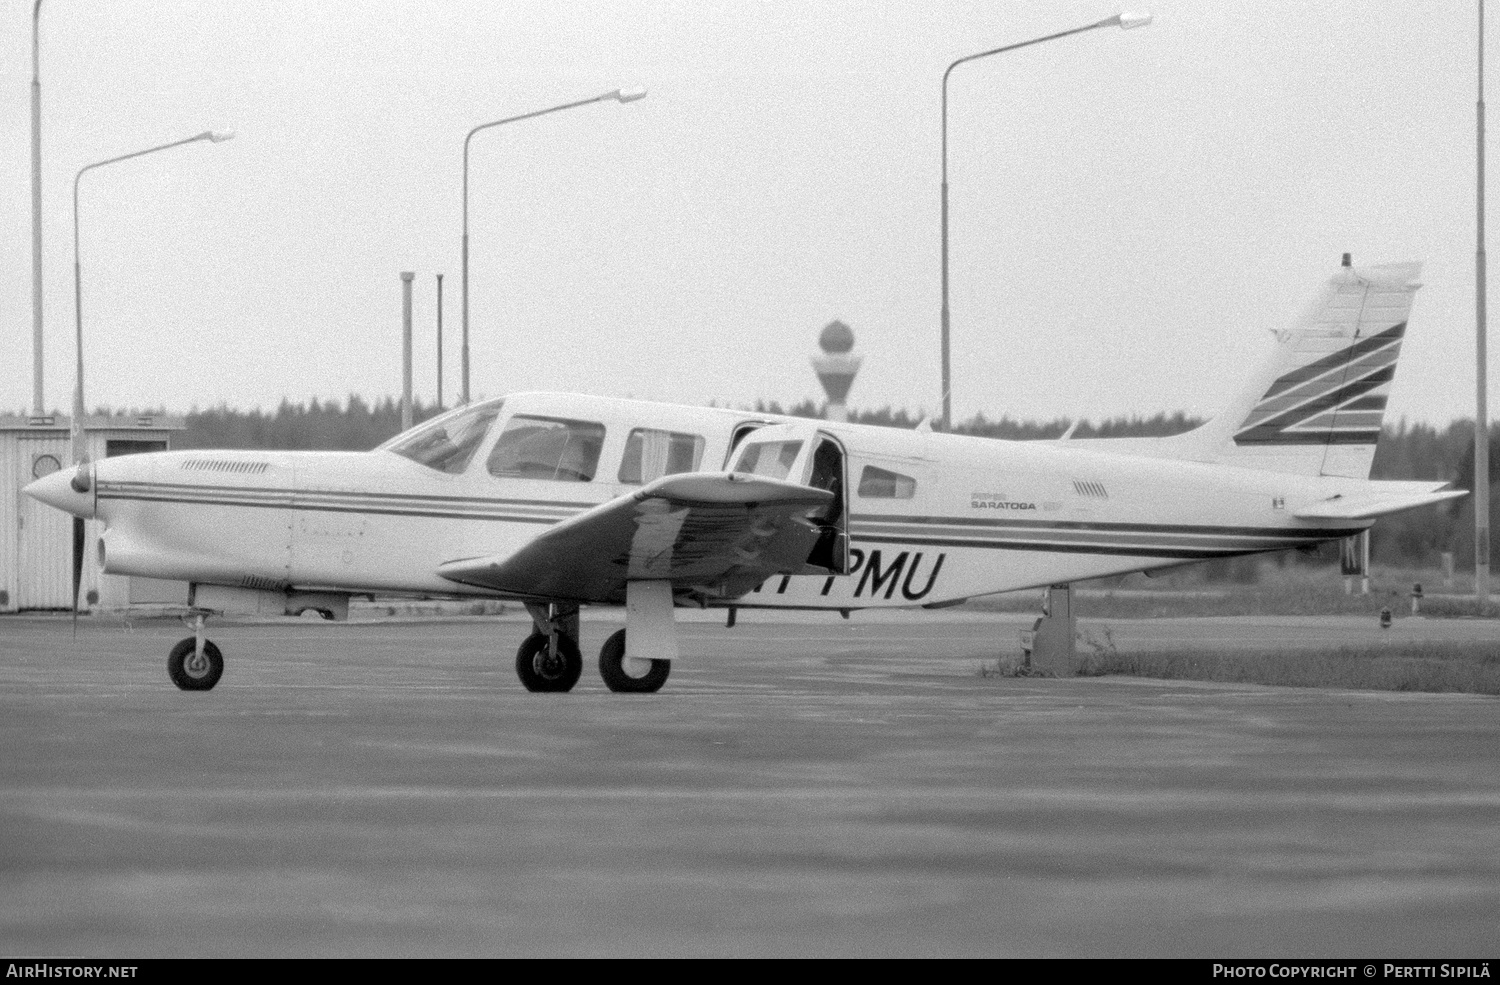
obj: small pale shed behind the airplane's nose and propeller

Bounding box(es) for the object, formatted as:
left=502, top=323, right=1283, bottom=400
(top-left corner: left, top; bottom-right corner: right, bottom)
left=0, top=414, right=188, bottom=612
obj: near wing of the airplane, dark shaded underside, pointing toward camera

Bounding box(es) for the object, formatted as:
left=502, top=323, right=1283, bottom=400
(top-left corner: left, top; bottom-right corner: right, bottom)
left=438, top=472, right=833, bottom=604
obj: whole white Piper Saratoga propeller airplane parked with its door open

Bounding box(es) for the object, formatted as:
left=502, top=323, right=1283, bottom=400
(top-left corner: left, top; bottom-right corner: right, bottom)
left=26, top=258, right=1466, bottom=693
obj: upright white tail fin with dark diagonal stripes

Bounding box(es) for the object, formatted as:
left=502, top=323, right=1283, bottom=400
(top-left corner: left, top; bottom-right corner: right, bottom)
left=1091, top=262, right=1422, bottom=478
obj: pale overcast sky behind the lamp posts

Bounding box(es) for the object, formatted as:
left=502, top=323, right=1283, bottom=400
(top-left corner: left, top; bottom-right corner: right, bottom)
left=0, top=0, right=1500, bottom=424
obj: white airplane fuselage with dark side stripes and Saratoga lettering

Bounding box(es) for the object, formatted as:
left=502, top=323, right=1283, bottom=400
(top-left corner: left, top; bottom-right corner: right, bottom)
left=61, top=394, right=1370, bottom=609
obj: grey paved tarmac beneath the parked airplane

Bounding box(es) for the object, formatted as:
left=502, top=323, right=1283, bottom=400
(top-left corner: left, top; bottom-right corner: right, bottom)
left=0, top=610, right=1500, bottom=973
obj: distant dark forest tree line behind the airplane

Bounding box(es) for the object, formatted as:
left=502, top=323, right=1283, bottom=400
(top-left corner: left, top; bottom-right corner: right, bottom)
left=135, top=394, right=1500, bottom=568
